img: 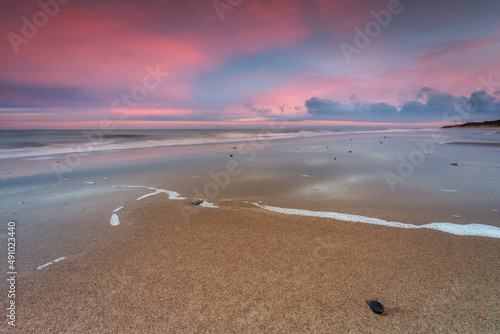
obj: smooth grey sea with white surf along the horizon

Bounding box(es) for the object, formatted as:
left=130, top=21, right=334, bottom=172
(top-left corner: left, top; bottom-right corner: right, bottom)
left=0, top=127, right=500, bottom=160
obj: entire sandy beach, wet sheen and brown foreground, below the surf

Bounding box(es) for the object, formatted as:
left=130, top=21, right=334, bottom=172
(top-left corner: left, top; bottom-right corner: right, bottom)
left=0, top=127, right=500, bottom=333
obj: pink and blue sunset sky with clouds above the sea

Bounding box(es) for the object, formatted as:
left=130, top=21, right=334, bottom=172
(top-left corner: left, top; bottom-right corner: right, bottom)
left=0, top=0, right=500, bottom=129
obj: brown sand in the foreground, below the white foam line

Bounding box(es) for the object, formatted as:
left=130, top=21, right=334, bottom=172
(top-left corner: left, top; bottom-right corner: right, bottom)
left=6, top=199, right=500, bottom=333
